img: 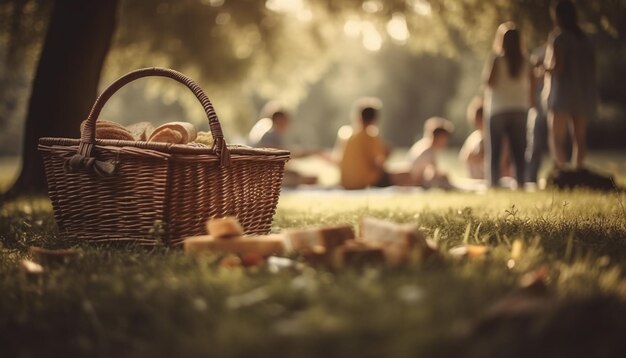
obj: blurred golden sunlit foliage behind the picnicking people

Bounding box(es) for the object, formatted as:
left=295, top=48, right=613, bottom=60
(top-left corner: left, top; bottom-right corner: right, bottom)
left=0, top=0, right=626, bottom=194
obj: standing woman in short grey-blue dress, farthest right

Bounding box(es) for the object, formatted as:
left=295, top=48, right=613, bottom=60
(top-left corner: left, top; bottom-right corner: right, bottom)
left=544, top=0, right=597, bottom=168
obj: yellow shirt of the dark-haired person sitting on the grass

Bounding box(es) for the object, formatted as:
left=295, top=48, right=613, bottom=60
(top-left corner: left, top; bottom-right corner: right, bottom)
left=339, top=126, right=386, bottom=189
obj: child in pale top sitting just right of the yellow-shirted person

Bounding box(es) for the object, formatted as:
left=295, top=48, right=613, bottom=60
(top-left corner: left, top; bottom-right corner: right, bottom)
left=408, top=117, right=454, bottom=189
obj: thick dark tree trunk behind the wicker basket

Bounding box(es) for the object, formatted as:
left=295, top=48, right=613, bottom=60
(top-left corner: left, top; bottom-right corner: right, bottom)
left=8, top=0, right=118, bottom=196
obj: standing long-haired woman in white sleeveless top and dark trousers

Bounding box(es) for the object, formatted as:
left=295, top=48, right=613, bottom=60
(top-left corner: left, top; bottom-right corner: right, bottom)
left=485, top=22, right=531, bottom=188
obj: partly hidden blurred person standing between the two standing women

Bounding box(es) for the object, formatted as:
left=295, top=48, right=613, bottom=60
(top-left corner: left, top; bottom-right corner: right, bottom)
left=525, top=46, right=548, bottom=183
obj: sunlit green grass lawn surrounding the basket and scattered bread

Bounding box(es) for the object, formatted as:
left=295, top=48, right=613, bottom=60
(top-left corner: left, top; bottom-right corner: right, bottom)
left=0, top=191, right=626, bottom=357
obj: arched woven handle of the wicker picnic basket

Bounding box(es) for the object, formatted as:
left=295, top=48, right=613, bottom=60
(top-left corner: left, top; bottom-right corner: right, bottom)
left=78, top=67, right=230, bottom=166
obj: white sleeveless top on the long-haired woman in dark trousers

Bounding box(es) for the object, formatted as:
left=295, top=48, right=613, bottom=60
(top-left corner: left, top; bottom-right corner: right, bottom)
left=485, top=56, right=530, bottom=116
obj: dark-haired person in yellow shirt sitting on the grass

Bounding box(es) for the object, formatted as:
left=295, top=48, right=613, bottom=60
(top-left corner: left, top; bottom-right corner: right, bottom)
left=339, top=98, right=391, bottom=189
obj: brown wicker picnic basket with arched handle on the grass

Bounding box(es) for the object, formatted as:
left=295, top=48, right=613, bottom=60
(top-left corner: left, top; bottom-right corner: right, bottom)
left=39, top=68, right=289, bottom=245
